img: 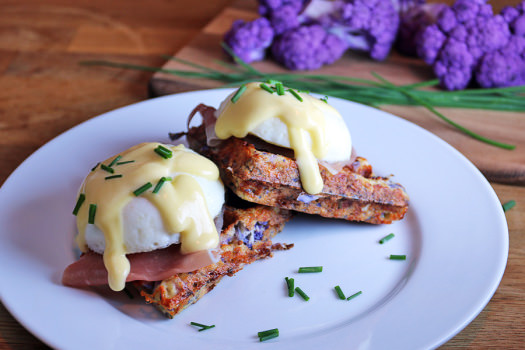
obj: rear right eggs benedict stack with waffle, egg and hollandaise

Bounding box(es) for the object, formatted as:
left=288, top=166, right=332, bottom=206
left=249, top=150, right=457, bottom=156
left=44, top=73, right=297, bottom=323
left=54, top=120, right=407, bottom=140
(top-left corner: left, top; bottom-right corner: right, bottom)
left=187, top=82, right=408, bottom=224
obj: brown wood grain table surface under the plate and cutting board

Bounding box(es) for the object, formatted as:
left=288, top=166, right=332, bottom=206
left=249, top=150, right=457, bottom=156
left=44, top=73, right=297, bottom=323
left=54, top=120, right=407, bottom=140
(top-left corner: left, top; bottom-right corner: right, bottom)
left=0, top=0, right=525, bottom=349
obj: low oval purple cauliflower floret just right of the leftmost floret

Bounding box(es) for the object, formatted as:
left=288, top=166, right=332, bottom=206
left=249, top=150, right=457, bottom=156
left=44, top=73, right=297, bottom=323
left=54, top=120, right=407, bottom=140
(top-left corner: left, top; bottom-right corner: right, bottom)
left=272, top=25, right=346, bottom=70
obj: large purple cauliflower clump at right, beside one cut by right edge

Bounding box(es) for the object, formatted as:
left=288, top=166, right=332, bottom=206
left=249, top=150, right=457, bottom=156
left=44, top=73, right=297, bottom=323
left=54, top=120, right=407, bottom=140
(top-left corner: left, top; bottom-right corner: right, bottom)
left=416, top=0, right=511, bottom=90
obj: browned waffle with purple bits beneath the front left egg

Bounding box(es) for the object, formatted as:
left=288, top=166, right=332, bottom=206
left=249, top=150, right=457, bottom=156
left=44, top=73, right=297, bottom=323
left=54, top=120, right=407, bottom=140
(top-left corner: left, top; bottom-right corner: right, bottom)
left=133, top=205, right=293, bottom=318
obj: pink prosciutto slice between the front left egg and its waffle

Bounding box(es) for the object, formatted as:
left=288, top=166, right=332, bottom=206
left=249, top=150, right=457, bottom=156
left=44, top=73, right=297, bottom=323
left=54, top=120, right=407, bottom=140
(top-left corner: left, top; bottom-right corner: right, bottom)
left=62, top=244, right=217, bottom=287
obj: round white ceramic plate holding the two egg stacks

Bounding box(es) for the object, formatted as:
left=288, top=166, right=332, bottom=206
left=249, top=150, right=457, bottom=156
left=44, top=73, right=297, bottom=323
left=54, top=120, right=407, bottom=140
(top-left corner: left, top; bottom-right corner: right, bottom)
left=0, top=90, right=508, bottom=349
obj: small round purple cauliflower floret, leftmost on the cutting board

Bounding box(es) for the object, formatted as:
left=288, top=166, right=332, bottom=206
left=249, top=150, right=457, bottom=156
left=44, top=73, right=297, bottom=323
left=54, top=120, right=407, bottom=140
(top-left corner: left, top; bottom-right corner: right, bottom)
left=224, top=17, right=274, bottom=63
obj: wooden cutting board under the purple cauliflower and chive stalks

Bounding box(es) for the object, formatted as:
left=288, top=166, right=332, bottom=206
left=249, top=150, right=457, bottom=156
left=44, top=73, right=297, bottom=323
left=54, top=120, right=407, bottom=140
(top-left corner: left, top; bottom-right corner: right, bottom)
left=150, top=0, right=525, bottom=185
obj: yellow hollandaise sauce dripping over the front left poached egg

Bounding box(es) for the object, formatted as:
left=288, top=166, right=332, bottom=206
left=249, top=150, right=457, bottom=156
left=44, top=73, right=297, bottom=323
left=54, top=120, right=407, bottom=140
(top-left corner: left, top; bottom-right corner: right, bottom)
left=73, top=143, right=219, bottom=291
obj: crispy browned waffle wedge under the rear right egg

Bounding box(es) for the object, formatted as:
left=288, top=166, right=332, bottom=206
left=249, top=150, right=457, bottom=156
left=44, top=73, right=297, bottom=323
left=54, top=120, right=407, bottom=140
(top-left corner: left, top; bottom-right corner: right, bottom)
left=182, top=104, right=408, bottom=224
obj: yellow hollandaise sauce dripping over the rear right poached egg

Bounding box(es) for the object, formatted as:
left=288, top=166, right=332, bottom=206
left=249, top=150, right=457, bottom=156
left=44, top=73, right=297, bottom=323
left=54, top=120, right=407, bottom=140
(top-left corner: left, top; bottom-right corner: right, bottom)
left=215, top=82, right=337, bottom=194
